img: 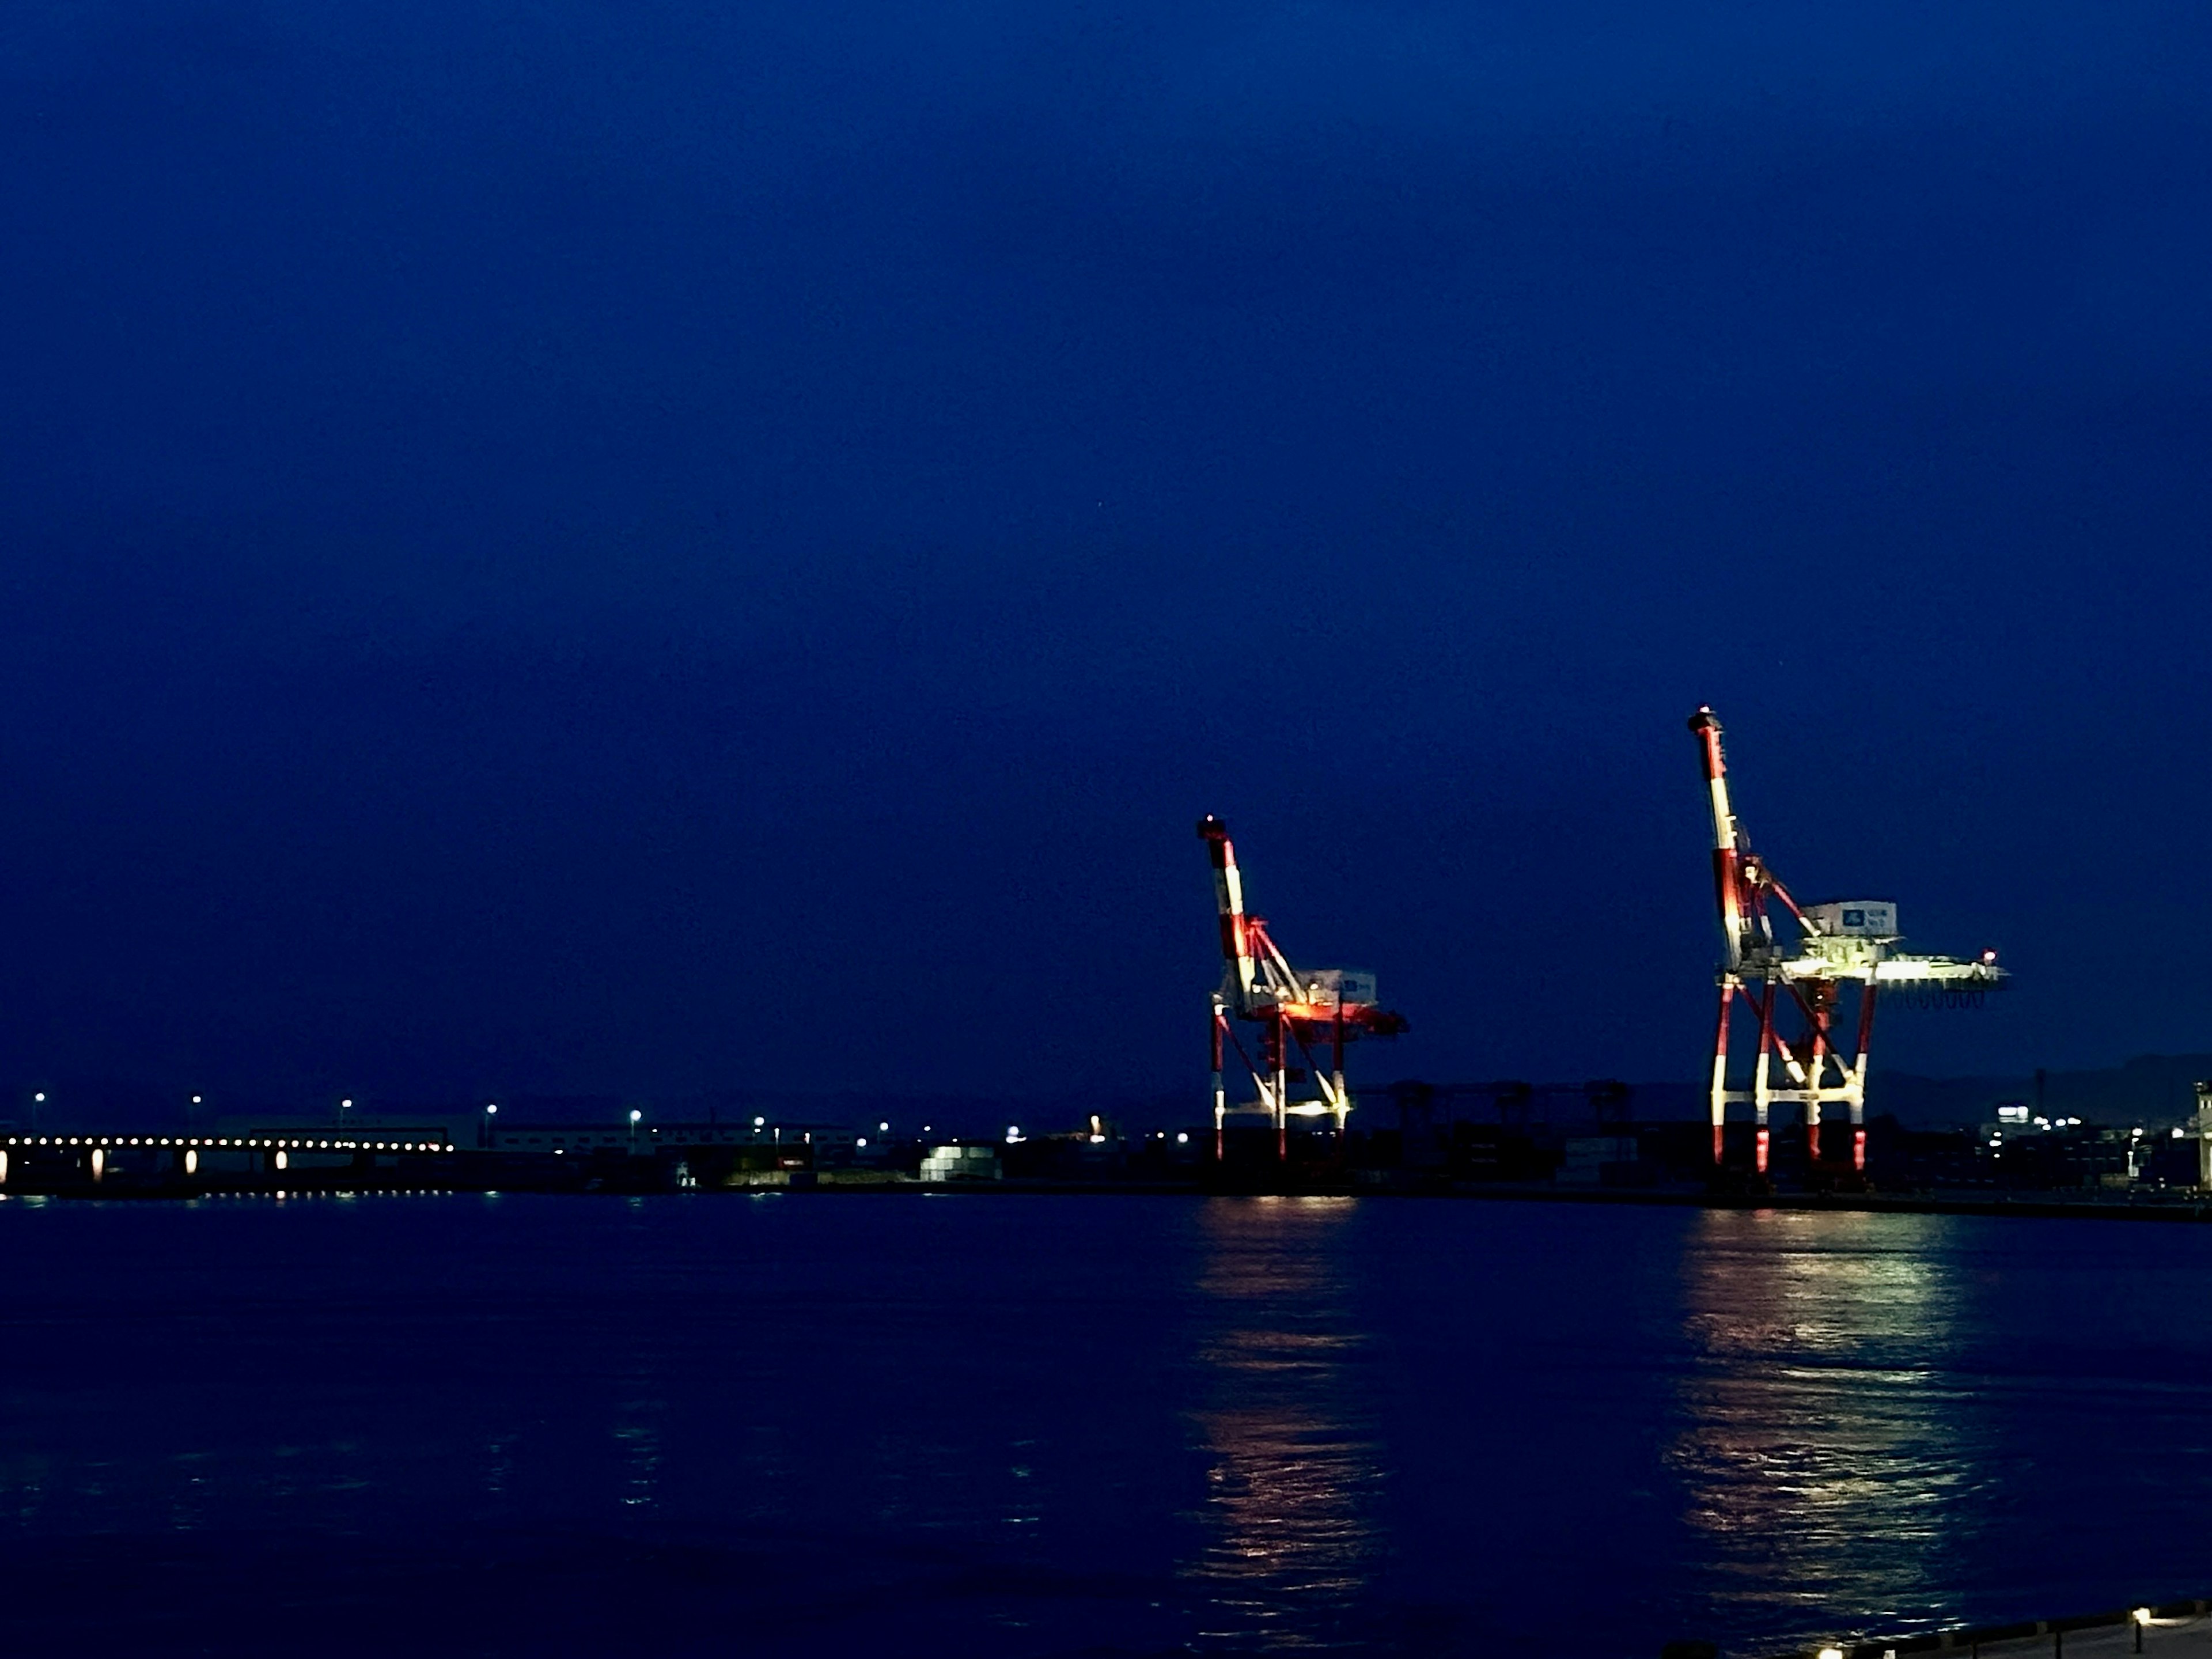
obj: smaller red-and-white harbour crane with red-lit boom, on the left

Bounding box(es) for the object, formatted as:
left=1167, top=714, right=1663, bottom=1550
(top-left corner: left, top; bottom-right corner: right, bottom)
left=1199, top=814, right=1404, bottom=1159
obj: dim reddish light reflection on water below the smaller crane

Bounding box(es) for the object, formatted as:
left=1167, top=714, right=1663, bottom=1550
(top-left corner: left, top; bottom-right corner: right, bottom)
left=1183, top=1199, right=1382, bottom=1650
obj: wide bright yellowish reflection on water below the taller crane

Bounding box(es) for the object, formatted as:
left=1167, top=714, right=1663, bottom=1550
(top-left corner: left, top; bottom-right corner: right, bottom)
left=1672, top=1210, right=1986, bottom=1635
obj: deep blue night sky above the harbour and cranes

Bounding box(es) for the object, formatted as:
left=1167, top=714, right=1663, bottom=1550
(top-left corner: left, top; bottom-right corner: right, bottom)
left=0, top=0, right=2212, bottom=1119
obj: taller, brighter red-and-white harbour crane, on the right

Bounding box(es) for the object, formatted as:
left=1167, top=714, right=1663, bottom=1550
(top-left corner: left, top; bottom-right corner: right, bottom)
left=1690, top=708, right=2009, bottom=1175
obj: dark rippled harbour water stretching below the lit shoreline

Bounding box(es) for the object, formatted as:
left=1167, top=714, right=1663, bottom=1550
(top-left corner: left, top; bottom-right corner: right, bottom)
left=0, top=1195, right=2212, bottom=1657
